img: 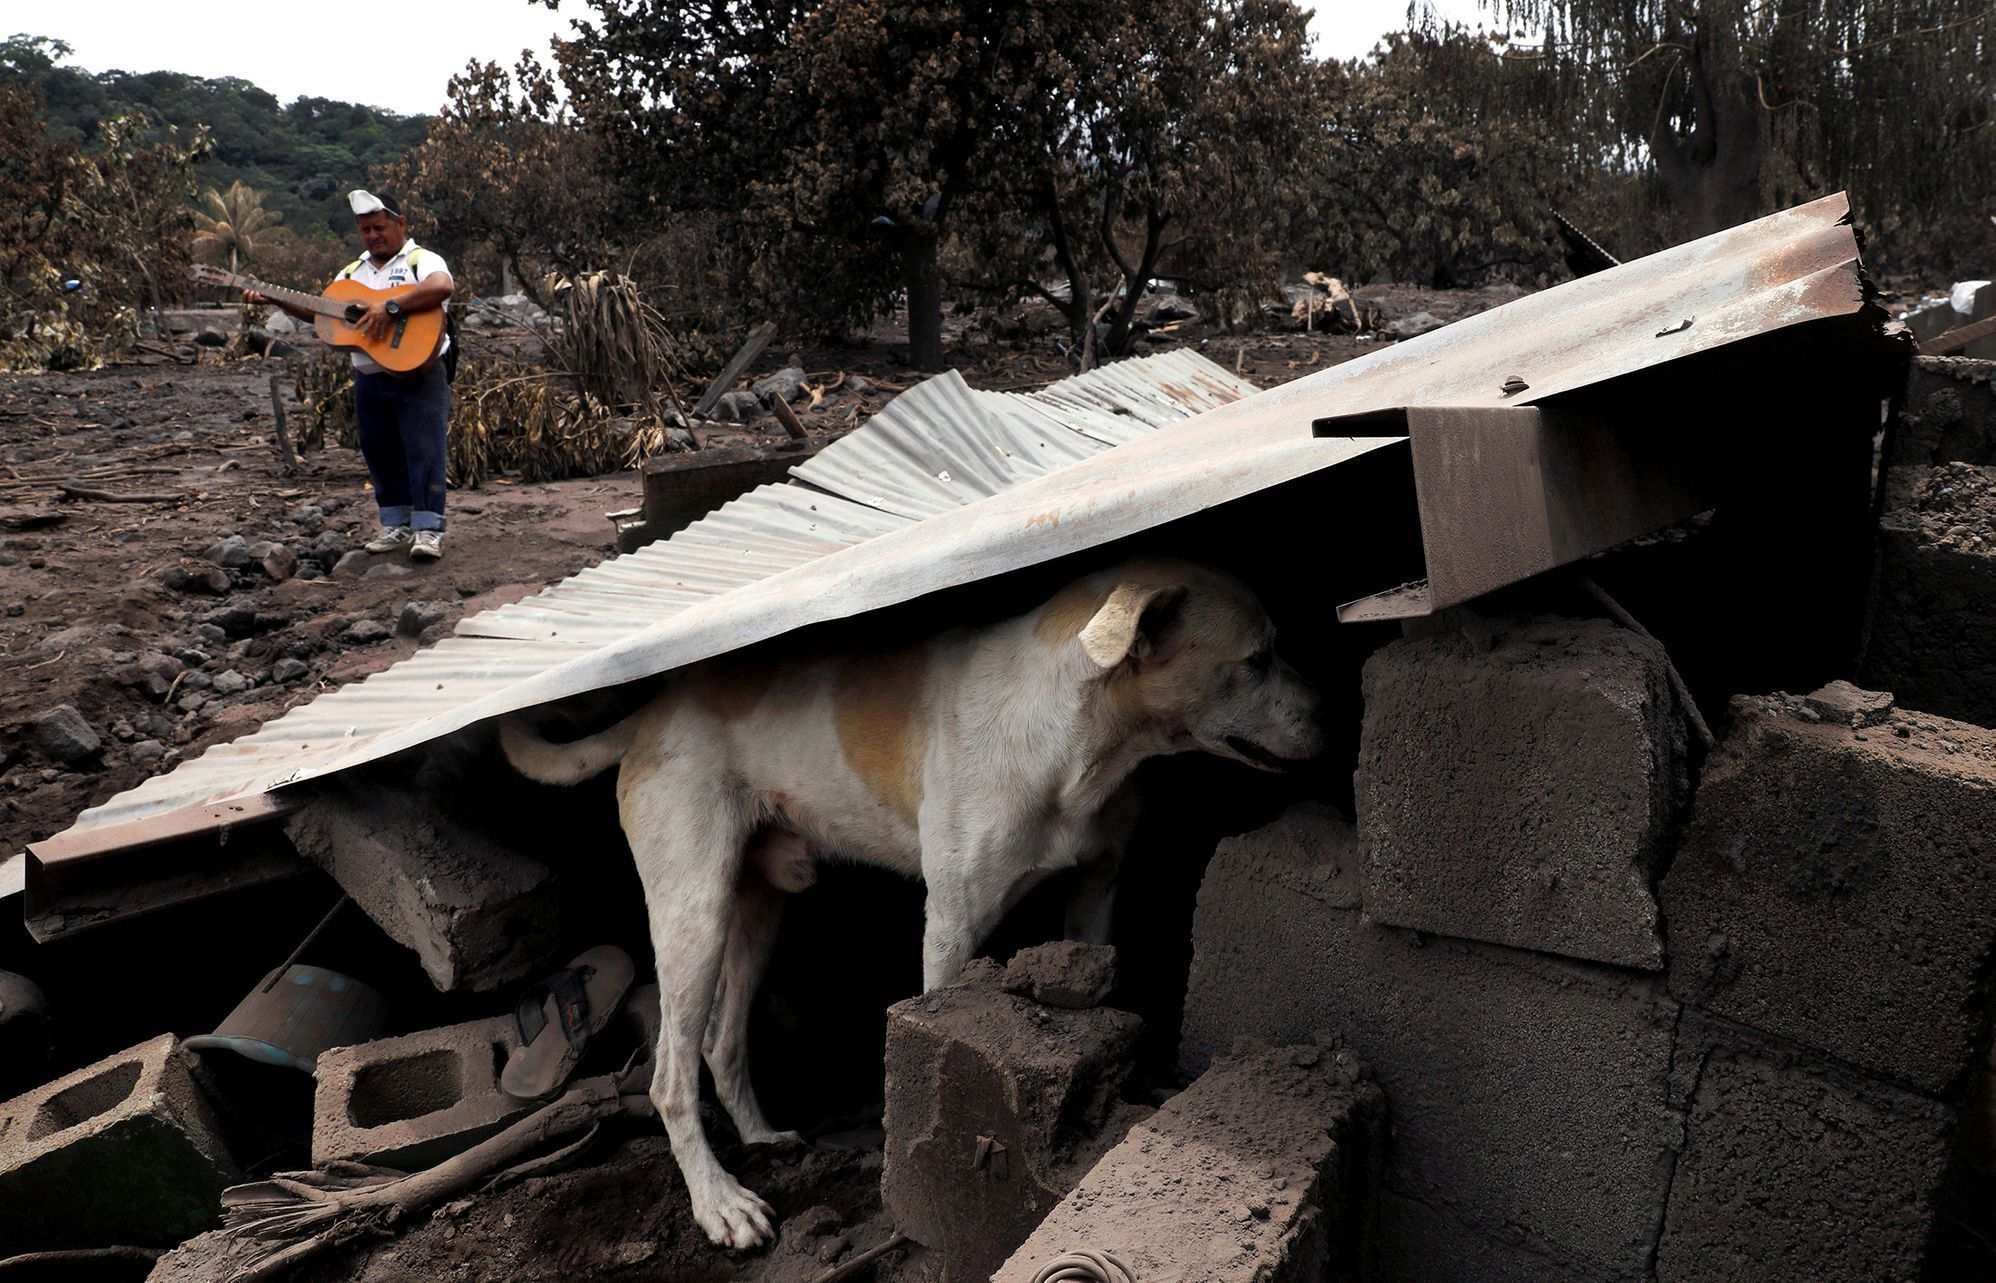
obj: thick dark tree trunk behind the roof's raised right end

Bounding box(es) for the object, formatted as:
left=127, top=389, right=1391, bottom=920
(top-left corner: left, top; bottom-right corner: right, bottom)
left=1651, top=48, right=1768, bottom=235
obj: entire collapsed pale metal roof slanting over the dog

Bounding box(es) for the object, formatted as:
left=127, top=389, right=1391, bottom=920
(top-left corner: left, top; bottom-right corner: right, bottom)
left=34, top=196, right=1900, bottom=893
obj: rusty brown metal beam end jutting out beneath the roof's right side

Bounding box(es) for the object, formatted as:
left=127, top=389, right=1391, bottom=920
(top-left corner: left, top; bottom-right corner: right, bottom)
left=1317, top=405, right=1729, bottom=623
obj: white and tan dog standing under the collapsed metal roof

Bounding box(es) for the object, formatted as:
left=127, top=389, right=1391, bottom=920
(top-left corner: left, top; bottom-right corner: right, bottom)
left=503, top=559, right=1321, bottom=1247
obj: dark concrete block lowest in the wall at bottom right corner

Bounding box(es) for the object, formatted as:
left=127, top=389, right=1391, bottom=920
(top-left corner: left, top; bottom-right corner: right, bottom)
left=1657, top=1012, right=1954, bottom=1283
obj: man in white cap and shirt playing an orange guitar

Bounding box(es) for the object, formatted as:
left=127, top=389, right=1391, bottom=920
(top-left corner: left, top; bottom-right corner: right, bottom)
left=244, top=192, right=451, bottom=561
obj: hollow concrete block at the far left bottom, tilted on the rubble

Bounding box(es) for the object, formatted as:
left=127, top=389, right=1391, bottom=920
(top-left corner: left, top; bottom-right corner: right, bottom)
left=0, top=1034, right=238, bottom=1257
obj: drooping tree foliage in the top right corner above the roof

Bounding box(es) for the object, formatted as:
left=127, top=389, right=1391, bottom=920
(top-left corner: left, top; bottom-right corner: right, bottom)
left=1461, top=0, right=1996, bottom=265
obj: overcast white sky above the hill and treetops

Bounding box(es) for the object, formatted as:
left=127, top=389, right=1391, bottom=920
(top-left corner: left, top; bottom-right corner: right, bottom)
left=19, top=0, right=1487, bottom=114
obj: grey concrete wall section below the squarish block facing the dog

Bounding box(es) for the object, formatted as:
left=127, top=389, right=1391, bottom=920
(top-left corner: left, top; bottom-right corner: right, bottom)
left=1180, top=806, right=1679, bottom=1279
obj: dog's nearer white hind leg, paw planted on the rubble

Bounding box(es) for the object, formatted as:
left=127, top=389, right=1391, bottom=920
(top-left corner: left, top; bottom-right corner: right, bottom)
left=619, top=758, right=774, bottom=1247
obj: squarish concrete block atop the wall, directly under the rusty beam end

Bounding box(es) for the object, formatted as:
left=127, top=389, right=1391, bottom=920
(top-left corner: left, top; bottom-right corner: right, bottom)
left=1357, top=617, right=1687, bottom=968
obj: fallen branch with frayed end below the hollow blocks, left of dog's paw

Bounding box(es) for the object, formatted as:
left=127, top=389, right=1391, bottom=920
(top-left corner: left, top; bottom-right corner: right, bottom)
left=222, top=1075, right=651, bottom=1283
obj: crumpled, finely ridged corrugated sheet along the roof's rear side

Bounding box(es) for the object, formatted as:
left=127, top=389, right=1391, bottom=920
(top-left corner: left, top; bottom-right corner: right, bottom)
left=38, top=351, right=1253, bottom=854
